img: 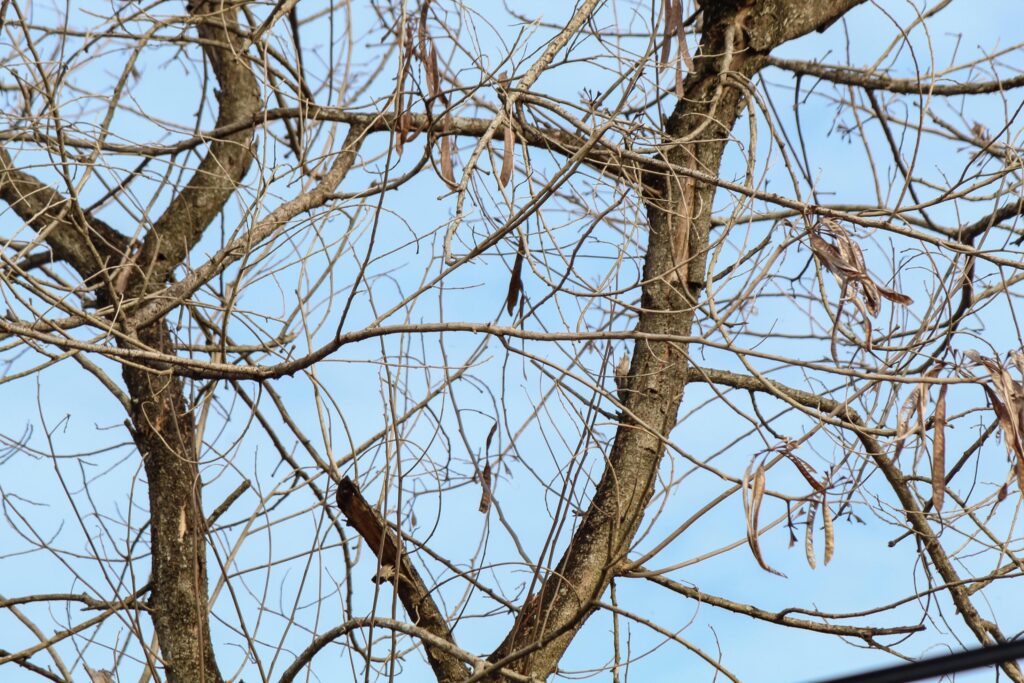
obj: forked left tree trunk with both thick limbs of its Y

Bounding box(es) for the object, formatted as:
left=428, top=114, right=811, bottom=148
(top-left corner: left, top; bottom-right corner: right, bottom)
left=0, top=0, right=261, bottom=683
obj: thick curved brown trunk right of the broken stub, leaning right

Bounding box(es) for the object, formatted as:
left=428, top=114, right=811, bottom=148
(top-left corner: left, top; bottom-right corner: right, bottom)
left=489, top=0, right=860, bottom=678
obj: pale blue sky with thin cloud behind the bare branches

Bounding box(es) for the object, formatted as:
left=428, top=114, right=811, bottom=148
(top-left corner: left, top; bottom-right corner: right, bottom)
left=0, top=0, right=1024, bottom=683
